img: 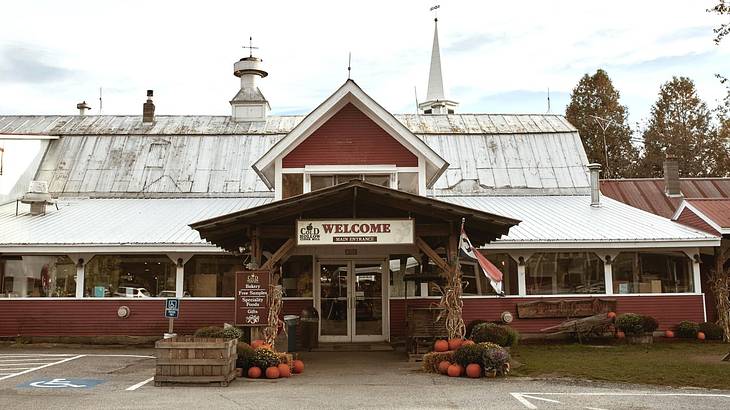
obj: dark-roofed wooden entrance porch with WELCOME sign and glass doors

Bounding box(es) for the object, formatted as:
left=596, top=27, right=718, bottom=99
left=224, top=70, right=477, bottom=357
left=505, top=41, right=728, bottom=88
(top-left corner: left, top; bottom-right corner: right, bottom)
left=191, top=180, right=518, bottom=343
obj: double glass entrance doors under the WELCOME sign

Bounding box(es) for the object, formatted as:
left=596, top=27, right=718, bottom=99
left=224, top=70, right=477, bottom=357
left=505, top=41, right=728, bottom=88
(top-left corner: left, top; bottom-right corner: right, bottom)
left=318, top=261, right=387, bottom=342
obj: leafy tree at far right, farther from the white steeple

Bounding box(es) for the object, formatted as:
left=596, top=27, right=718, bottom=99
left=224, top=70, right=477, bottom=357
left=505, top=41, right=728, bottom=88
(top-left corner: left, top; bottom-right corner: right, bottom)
left=640, top=77, right=728, bottom=177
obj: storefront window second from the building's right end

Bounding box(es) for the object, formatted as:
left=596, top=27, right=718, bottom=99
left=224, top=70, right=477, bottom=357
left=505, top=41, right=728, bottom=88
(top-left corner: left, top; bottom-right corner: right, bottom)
left=525, top=252, right=606, bottom=295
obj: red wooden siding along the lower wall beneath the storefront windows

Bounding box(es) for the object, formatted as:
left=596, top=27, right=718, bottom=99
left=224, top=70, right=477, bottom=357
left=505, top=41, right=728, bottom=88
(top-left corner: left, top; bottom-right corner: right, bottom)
left=0, top=295, right=703, bottom=337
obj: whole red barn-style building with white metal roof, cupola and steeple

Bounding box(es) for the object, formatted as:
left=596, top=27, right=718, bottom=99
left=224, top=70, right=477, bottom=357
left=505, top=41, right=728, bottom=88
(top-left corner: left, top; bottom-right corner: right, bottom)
left=0, top=21, right=720, bottom=343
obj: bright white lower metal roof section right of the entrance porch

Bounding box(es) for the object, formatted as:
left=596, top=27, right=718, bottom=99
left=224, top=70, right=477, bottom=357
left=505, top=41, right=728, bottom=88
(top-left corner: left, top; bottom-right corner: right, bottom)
left=440, top=196, right=719, bottom=248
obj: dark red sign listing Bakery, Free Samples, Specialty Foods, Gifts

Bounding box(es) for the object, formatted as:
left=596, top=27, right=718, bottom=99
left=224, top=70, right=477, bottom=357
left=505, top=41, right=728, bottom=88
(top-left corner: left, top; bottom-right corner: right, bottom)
left=235, top=271, right=270, bottom=326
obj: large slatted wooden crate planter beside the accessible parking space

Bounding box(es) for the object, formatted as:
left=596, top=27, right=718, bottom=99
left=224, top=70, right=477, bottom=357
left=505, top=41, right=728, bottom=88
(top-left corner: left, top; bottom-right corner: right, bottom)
left=155, top=336, right=238, bottom=387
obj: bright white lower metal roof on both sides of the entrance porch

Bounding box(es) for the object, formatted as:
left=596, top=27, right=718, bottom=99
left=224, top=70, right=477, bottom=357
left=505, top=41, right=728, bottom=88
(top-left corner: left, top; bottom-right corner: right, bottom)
left=0, top=196, right=720, bottom=249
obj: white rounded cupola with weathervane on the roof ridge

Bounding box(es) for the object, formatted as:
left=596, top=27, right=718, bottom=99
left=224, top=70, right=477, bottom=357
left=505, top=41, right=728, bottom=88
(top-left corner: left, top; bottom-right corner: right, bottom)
left=231, top=42, right=271, bottom=121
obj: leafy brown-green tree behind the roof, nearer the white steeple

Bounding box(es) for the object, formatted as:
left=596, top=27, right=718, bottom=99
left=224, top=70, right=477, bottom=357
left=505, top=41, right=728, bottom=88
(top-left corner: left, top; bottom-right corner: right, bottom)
left=565, top=69, right=639, bottom=178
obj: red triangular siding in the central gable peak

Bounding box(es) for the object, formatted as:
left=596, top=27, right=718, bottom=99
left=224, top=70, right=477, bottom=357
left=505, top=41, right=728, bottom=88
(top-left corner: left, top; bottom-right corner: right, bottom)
left=282, top=104, right=418, bottom=168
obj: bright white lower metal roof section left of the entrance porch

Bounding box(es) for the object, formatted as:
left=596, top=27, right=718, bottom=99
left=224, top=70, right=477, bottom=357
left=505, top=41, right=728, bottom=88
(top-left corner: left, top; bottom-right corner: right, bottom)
left=0, top=198, right=271, bottom=246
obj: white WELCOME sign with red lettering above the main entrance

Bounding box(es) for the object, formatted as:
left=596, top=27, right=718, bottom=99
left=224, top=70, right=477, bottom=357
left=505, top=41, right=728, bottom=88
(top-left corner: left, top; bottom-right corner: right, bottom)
left=296, top=219, right=415, bottom=246
